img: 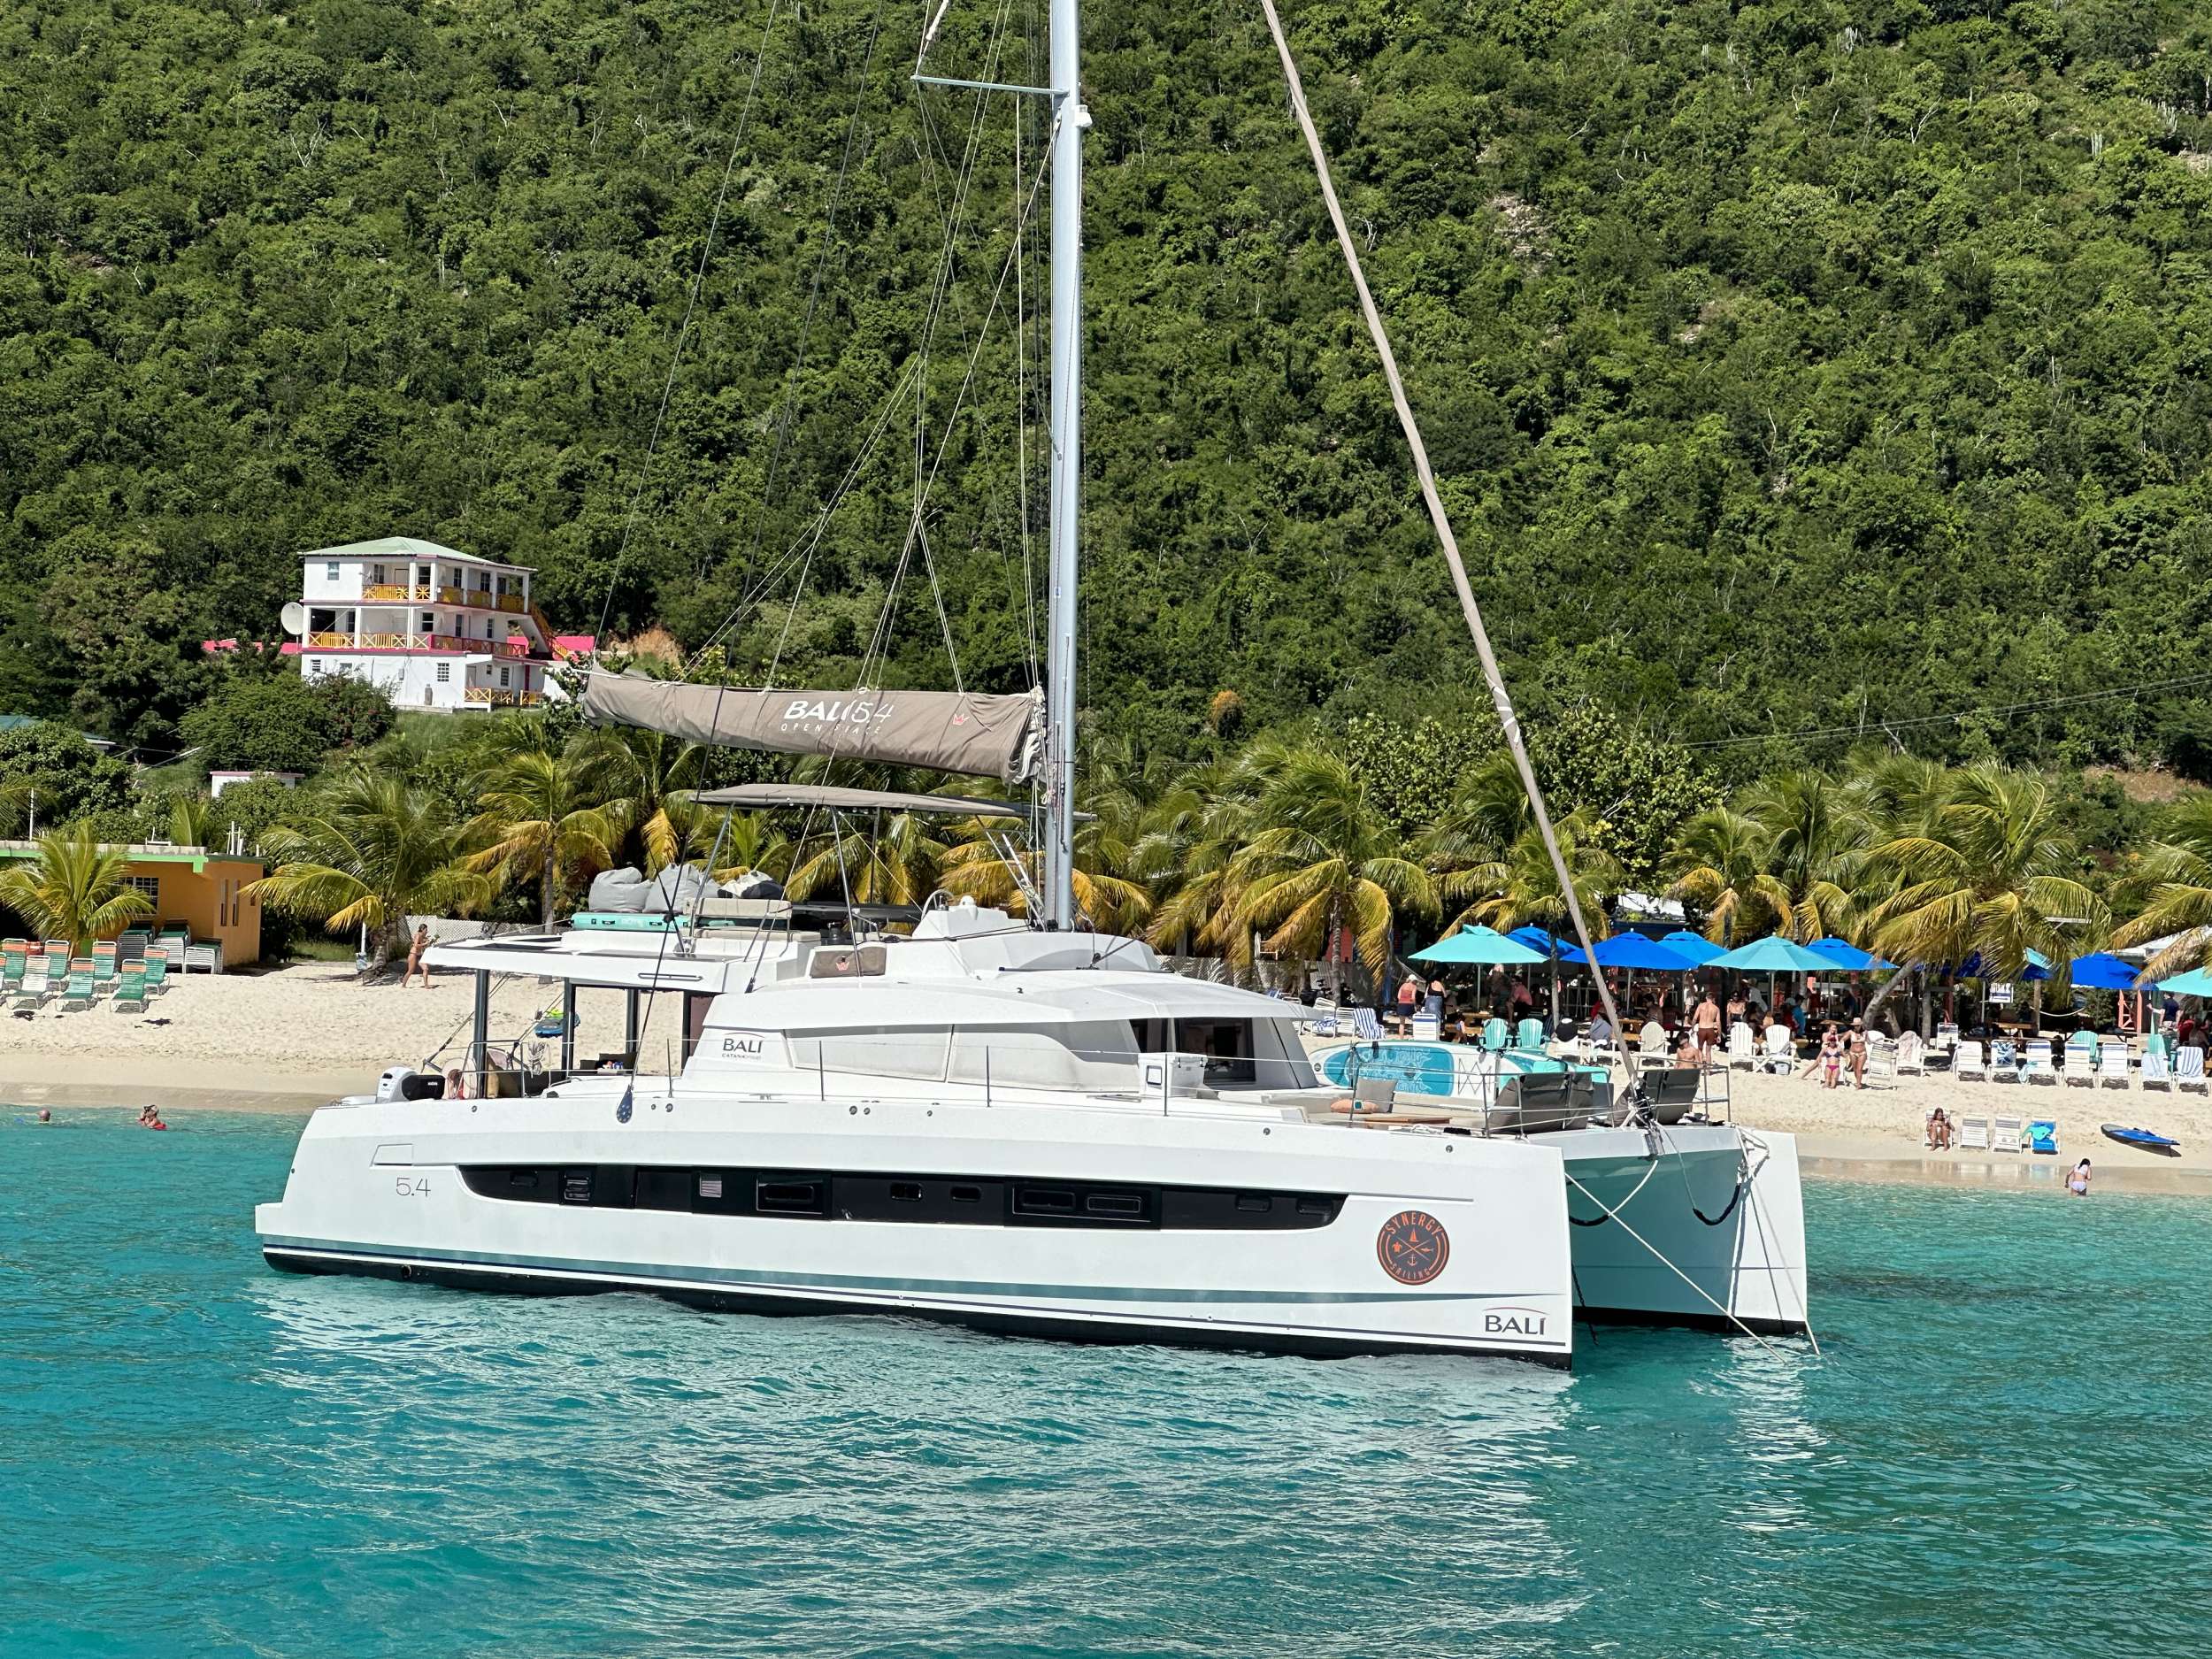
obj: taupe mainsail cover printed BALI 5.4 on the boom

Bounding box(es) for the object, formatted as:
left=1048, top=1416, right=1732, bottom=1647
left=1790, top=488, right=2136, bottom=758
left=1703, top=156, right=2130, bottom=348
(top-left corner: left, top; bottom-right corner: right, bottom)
left=580, top=671, right=1042, bottom=783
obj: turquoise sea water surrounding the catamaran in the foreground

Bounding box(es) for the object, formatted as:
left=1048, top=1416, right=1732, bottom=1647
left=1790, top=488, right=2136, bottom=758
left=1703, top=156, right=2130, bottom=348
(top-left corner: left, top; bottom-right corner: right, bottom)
left=0, top=1113, right=2212, bottom=1659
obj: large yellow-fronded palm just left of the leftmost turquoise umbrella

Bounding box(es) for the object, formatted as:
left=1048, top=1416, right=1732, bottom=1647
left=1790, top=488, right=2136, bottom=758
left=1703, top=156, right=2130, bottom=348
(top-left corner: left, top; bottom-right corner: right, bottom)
left=1228, top=748, right=1440, bottom=995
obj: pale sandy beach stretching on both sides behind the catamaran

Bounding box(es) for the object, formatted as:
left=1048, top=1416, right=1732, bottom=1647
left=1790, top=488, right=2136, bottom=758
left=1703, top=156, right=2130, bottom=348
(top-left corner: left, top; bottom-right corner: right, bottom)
left=0, top=963, right=2212, bottom=1194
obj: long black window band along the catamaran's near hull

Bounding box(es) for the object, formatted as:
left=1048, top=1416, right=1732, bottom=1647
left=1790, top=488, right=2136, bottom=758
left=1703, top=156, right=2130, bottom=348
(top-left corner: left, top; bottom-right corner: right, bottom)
left=460, top=1164, right=1345, bottom=1233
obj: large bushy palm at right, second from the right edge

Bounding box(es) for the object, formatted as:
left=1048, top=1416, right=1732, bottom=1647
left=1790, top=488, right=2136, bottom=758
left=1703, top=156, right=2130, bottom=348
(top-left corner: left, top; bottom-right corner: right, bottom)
left=1865, top=765, right=2106, bottom=978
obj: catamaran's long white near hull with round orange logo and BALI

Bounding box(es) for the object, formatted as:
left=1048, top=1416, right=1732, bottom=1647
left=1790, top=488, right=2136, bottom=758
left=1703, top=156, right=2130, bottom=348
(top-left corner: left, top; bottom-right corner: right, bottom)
left=255, top=1087, right=1573, bottom=1365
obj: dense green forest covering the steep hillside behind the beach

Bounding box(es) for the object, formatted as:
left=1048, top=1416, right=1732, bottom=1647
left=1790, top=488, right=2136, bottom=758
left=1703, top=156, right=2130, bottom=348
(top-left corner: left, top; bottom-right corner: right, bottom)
left=0, top=0, right=2212, bottom=787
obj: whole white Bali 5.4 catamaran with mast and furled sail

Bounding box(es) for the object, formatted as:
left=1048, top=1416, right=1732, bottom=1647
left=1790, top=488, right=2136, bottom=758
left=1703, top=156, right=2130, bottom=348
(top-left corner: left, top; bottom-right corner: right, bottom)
left=255, top=0, right=1805, bottom=1365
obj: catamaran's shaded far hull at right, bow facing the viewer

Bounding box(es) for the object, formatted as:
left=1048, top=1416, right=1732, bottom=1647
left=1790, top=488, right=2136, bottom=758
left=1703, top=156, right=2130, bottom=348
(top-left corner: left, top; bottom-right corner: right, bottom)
left=1540, top=1124, right=1809, bottom=1336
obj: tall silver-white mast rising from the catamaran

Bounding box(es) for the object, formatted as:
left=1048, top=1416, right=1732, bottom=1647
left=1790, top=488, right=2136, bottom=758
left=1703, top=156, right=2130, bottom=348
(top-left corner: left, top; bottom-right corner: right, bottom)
left=1044, top=0, right=1091, bottom=927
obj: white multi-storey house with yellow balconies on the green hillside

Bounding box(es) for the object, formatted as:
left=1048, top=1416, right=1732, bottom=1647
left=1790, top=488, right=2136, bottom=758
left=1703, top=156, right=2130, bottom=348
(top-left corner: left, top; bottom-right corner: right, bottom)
left=288, top=535, right=556, bottom=710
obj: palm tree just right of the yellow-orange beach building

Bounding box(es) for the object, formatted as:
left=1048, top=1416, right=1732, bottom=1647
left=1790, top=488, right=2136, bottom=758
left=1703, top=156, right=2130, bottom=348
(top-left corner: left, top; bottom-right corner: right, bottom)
left=246, top=761, right=495, bottom=973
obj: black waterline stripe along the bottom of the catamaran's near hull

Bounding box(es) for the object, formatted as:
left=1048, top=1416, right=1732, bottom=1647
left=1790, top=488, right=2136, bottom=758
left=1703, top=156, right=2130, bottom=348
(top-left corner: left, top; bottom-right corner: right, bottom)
left=261, top=1246, right=1573, bottom=1370
